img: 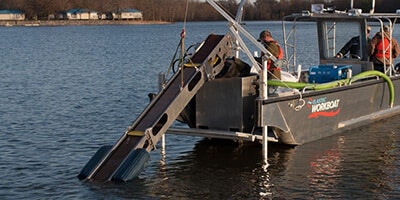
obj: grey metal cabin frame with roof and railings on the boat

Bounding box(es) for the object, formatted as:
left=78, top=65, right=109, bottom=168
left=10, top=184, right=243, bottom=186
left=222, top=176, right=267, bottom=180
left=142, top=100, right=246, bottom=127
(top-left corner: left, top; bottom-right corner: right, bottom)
left=282, top=5, right=400, bottom=76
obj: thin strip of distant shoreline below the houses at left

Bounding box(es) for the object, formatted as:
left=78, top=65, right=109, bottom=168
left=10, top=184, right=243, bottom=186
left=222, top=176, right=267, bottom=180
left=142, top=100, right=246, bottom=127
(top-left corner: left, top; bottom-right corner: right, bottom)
left=0, top=20, right=171, bottom=26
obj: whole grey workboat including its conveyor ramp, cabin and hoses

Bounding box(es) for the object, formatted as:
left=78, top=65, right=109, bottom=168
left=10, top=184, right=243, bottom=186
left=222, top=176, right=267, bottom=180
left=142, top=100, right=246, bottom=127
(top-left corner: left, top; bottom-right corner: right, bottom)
left=78, top=0, right=400, bottom=182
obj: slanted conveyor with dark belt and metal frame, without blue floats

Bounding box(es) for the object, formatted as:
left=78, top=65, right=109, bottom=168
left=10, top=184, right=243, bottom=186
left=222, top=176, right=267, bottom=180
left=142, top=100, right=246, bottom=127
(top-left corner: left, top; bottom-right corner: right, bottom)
left=87, top=35, right=230, bottom=181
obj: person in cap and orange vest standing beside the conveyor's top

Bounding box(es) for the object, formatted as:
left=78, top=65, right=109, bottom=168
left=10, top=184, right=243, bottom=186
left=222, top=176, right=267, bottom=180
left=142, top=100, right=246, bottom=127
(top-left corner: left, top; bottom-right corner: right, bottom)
left=258, top=30, right=283, bottom=79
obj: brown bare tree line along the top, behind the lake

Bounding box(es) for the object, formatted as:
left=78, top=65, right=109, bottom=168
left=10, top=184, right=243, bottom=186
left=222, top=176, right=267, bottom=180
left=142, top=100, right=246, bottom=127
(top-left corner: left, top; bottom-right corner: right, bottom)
left=0, top=0, right=400, bottom=22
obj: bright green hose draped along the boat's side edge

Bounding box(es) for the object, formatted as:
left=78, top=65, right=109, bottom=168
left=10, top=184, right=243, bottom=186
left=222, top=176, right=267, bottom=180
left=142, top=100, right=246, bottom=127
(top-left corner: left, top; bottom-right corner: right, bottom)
left=267, top=70, right=394, bottom=107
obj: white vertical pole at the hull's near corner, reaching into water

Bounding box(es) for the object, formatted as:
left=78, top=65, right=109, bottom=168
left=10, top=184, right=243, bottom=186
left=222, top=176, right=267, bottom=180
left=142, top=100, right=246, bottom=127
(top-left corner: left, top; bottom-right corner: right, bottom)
left=260, top=59, right=268, bottom=169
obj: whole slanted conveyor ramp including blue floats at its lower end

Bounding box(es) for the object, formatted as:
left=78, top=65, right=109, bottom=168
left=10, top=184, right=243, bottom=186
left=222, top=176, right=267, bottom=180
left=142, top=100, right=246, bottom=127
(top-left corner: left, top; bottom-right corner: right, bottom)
left=78, top=34, right=231, bottom=182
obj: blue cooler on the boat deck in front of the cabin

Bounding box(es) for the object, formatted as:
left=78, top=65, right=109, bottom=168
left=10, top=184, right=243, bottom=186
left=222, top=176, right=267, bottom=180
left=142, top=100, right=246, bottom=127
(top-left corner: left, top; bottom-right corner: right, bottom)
left=308, top=65, right=351, bottom=83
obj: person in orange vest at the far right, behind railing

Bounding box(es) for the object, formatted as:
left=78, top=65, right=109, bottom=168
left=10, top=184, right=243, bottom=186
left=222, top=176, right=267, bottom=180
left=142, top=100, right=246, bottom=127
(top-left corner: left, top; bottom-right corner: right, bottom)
left=369, top=25, right=400, bottom=73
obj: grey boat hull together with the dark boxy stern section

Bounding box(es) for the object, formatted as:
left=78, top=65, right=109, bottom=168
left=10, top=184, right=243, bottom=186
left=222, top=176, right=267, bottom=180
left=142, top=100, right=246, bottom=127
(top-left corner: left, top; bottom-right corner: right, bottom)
left=190, top=75, right=400, bottom=145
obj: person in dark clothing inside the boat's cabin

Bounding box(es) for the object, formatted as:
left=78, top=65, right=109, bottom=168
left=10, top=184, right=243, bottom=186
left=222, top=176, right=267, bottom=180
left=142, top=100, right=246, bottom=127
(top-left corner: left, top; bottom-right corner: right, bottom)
left=335, top=26, right=371, bottom=59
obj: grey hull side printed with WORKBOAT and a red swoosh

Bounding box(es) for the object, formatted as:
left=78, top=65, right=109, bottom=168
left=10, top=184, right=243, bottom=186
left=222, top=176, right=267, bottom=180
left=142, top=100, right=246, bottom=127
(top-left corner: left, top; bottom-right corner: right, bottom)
left=257, top=77, right=400, bottom=145
